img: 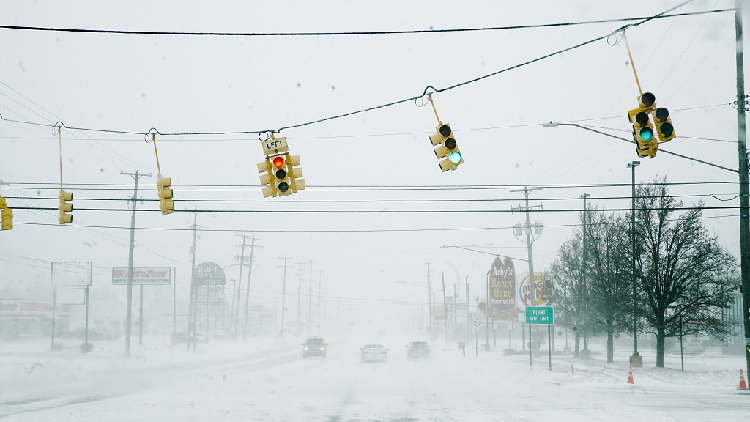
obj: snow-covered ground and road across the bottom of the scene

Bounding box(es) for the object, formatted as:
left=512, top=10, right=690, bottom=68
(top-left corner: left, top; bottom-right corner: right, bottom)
left=0, top=338, right=750, bottom=422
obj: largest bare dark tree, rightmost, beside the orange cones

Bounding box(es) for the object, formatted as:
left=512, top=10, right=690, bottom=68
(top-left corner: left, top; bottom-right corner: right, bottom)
left=635, top=178, right=739, bottom=367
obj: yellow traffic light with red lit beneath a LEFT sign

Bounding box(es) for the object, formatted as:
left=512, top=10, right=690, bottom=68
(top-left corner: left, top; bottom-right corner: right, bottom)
left=258, top=134, right=305, bottom=198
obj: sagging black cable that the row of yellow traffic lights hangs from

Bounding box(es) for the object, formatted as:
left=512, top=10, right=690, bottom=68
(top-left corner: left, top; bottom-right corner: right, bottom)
left=0, top=0, right=704, bottom=136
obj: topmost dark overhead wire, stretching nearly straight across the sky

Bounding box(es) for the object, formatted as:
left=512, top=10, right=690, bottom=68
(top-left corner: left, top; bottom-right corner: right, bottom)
left=0, top=9, right=734, bottom=37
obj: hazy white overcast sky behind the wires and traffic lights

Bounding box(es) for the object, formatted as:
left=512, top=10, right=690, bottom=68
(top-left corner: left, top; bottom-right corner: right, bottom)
left=0, top=0, right=739, bottom=320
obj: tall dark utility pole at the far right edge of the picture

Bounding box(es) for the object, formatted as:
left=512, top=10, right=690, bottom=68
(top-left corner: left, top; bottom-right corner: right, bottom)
left=734, top=0, right=750, bottom=382
